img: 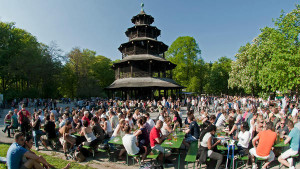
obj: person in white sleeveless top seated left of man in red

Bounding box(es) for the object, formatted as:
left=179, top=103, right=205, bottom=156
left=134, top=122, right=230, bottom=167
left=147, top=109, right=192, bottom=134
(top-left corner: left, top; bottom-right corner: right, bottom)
left=122, top=125, right=147, bottom=162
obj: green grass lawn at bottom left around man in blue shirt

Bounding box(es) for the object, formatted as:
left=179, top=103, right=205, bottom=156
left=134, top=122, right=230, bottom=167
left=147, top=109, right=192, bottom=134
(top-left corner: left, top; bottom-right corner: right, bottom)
left=0, top=143, right=93, bottom=169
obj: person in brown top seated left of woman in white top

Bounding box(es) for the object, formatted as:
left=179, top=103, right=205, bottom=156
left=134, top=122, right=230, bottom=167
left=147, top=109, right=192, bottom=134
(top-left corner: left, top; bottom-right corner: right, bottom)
left=59, top=120, right=76, bottom=158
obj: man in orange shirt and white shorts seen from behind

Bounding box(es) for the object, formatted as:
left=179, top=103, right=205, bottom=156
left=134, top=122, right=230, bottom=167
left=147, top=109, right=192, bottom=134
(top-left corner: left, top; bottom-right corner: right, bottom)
left=249, top=122, right=277, bottom=169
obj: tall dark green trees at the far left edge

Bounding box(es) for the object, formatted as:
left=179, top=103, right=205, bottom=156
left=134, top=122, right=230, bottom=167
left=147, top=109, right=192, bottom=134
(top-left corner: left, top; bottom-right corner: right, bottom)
left=0, top=22, right=61, bottom=100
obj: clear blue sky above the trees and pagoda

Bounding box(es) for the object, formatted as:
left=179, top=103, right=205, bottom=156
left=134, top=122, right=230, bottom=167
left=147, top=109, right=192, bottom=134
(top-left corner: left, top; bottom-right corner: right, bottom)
left=0, top=0, right=299, bottom=62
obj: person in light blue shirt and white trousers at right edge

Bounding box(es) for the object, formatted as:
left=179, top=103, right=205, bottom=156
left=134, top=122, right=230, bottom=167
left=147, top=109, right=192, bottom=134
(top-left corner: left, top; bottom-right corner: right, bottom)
left=278, top=120, right=300, bottom=169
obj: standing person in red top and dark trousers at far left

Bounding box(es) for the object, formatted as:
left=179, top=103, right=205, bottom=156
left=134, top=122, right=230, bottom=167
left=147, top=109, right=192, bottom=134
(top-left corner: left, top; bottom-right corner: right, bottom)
left=18, top=104, right=31, bottom=135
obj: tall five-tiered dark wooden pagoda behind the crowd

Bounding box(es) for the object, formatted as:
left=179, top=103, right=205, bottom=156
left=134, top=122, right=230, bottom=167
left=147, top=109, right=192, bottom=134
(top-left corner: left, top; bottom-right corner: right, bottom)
left=106, top=4, right=184, bottom=99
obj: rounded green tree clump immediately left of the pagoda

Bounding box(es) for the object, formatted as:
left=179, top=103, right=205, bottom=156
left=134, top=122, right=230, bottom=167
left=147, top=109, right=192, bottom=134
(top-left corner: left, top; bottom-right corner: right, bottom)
left=60, top=48, right=114, bottom=97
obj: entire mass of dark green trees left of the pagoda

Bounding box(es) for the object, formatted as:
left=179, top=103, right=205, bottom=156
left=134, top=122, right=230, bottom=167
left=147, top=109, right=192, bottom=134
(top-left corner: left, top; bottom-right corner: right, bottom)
left=0, top=22, right=114, bottom=100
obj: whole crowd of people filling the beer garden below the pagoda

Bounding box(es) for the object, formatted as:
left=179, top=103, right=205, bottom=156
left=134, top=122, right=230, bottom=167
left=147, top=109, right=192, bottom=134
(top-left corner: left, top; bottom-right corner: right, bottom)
left=3, top=96, right=300, bottom=169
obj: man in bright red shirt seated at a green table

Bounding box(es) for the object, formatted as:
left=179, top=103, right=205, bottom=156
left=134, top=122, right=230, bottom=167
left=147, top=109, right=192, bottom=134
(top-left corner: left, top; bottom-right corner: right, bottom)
left=150, top=120, right=171, bottom=163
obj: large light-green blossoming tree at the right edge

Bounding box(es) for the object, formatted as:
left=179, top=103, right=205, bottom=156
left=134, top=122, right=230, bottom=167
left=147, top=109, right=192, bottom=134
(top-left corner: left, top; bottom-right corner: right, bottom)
left=229, top=5, right=300, bottom=95
